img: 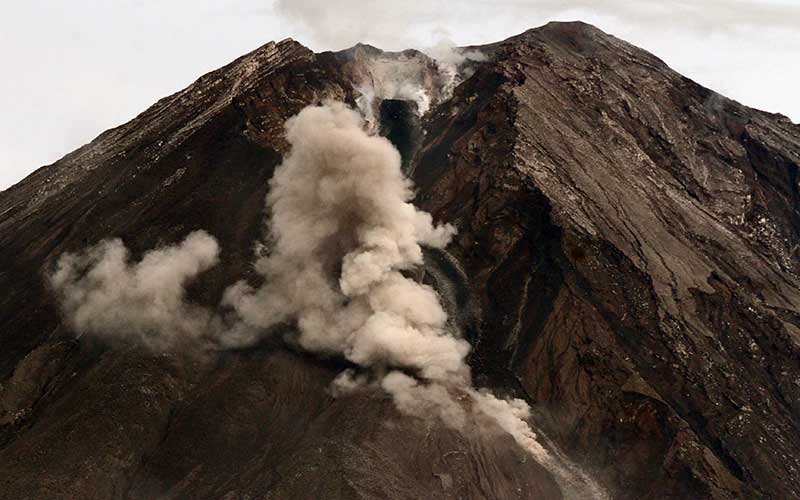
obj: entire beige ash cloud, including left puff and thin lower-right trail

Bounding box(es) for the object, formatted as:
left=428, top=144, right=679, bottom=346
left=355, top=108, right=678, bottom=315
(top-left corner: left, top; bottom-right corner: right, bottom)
left=50, top=103, right=604, bottom=498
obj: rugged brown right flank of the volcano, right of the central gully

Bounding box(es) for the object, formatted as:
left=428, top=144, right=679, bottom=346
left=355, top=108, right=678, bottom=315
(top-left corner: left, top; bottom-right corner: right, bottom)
left=415, top=23, right=800, bottom=498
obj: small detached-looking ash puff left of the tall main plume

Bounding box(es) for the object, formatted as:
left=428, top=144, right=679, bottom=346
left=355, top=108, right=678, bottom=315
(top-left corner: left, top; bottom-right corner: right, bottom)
left=48, top=231, right=219, bottom=350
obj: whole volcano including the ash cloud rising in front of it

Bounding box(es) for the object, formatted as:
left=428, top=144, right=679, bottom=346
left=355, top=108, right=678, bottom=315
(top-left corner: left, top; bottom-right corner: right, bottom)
left=0, top=23, right=800, bottom=500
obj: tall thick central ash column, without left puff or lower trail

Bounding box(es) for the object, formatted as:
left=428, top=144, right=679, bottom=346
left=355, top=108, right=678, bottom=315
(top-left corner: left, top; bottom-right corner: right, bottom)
left=220, top=103, right=469, bottom=379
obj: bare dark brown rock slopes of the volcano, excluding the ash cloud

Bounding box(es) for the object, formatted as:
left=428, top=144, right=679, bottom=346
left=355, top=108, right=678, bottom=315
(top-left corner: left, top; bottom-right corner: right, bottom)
left=0, top=23, right=800, bottom=499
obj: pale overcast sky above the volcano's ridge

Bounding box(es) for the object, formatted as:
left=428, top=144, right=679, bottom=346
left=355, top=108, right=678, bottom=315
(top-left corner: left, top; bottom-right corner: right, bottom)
left=0, top=0, right=800, bottom=189
